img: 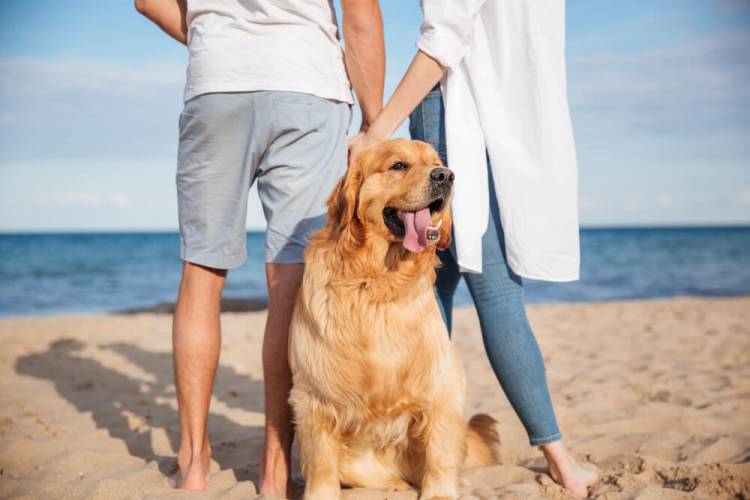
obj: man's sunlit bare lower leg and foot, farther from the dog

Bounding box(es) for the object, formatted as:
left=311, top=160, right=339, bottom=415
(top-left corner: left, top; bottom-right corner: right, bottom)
left=172, top=262, right=227, bottom=490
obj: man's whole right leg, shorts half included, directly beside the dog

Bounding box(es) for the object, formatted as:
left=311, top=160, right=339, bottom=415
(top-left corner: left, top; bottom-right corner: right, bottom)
left=253, top=91, right=351, bottom=496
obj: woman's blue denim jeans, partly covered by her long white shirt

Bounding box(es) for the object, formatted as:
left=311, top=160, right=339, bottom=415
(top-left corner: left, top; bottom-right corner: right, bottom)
left=409, top=87, right=562, bottom=446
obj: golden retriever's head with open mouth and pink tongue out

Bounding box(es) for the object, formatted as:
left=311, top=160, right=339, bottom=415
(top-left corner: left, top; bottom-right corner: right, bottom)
left=328, top=139, right=453, bottom=253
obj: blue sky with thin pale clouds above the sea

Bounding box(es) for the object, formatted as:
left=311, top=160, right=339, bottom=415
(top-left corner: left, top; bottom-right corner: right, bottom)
left=0, top=0, right=750, bottom=231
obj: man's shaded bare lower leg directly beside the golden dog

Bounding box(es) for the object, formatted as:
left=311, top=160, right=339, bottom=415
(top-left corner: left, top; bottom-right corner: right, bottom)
left=260, top=263, right=305, bottom=497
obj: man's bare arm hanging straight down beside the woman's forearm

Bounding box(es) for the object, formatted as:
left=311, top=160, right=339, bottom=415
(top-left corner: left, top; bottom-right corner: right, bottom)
left=341, top=0, right=385, bottom=131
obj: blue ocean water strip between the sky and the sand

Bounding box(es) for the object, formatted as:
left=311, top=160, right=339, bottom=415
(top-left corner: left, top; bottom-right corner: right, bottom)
left=0, top=227, right=750, bottom=316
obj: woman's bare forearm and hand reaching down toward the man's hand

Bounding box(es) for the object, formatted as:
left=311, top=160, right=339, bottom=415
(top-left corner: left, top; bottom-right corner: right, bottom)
left=349, top=50, right=445, bottom=161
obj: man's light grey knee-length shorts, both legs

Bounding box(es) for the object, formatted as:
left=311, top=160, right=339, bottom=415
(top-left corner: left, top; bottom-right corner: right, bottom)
left=177, top=91, right=351, bottom=269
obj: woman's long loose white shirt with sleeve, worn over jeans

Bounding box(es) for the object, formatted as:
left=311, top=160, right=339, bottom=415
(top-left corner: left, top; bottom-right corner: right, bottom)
left=417, top=0, right=580, bottom=281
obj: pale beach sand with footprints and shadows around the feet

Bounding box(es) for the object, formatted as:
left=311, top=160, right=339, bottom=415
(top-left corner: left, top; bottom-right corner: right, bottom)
left=0, top=298, right=750, bottom=500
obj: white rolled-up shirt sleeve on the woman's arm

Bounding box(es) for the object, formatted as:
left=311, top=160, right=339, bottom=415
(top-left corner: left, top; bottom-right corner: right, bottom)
left=417, top=0, right=486, bottom=68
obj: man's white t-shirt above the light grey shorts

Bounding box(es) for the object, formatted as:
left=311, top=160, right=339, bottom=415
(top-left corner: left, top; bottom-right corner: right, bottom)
left=185, top=0, right=353, bottom=104
